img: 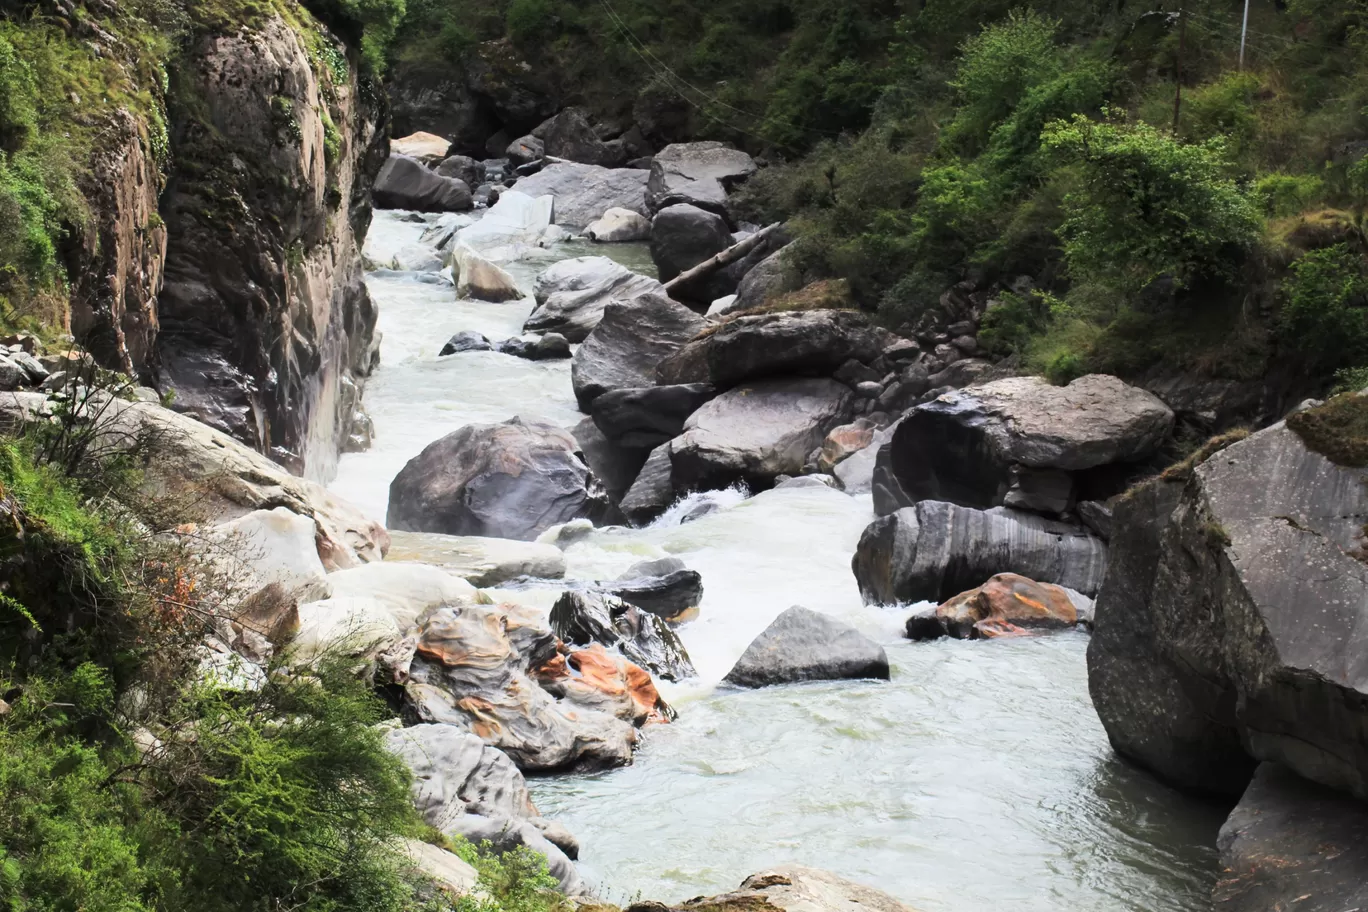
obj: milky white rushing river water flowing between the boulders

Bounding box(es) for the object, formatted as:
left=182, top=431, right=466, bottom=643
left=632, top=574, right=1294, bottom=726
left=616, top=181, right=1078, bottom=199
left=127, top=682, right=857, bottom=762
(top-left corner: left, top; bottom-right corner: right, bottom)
left=332, top=212, right=1224, bottom=912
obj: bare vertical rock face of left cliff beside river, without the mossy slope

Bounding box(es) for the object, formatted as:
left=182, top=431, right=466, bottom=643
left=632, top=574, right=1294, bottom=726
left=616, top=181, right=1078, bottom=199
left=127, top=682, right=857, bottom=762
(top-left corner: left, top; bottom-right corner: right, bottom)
left=156, top=16, right=386, bottom=477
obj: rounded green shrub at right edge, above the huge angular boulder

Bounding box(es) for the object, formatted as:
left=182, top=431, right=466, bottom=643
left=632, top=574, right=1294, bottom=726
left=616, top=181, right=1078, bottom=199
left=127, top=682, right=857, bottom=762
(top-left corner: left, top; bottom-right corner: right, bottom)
left=1279, top=243, right=1368, bottom=371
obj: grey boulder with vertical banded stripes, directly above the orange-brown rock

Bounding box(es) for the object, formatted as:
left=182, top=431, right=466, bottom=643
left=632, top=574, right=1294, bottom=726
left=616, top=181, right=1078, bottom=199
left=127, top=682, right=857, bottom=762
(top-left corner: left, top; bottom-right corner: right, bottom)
left=851, top=500, right=1107, bottom=604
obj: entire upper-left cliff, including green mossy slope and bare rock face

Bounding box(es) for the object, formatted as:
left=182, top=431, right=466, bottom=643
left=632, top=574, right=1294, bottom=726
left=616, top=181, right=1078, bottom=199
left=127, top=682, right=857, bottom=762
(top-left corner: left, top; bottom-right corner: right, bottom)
left=0, top=0, right=396, bottom=474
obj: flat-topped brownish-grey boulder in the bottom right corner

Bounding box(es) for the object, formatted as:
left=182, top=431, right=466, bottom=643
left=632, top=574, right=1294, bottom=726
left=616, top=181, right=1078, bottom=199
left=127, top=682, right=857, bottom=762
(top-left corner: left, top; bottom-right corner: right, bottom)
left=1212, top=763, right=1368, bottom=912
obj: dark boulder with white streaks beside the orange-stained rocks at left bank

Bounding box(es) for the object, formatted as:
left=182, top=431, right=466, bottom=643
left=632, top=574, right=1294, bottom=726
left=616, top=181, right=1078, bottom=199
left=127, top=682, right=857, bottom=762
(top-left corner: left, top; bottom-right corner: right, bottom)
left=551, top=592, right=698, bottom=681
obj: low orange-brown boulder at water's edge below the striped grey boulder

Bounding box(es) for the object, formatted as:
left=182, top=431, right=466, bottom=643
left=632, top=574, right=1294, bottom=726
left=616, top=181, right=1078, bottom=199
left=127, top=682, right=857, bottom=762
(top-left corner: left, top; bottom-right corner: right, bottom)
left=907, top=573, right=1079, bottom=640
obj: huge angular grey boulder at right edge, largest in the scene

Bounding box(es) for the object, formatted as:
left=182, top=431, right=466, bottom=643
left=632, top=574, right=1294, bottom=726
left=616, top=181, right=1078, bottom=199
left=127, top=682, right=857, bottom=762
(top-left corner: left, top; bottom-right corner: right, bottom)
left=1088, top=404, right=1368, bottom=797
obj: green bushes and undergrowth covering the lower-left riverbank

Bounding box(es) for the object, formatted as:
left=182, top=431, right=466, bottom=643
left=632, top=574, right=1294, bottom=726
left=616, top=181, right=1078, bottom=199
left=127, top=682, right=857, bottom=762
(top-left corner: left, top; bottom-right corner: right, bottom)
left=0, top=377, right=564, bottom=912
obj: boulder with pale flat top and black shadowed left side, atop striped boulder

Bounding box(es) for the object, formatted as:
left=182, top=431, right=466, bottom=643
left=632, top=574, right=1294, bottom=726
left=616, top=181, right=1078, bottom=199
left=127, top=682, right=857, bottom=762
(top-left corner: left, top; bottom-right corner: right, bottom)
left=889, top=373, right=1174, bottom=514
